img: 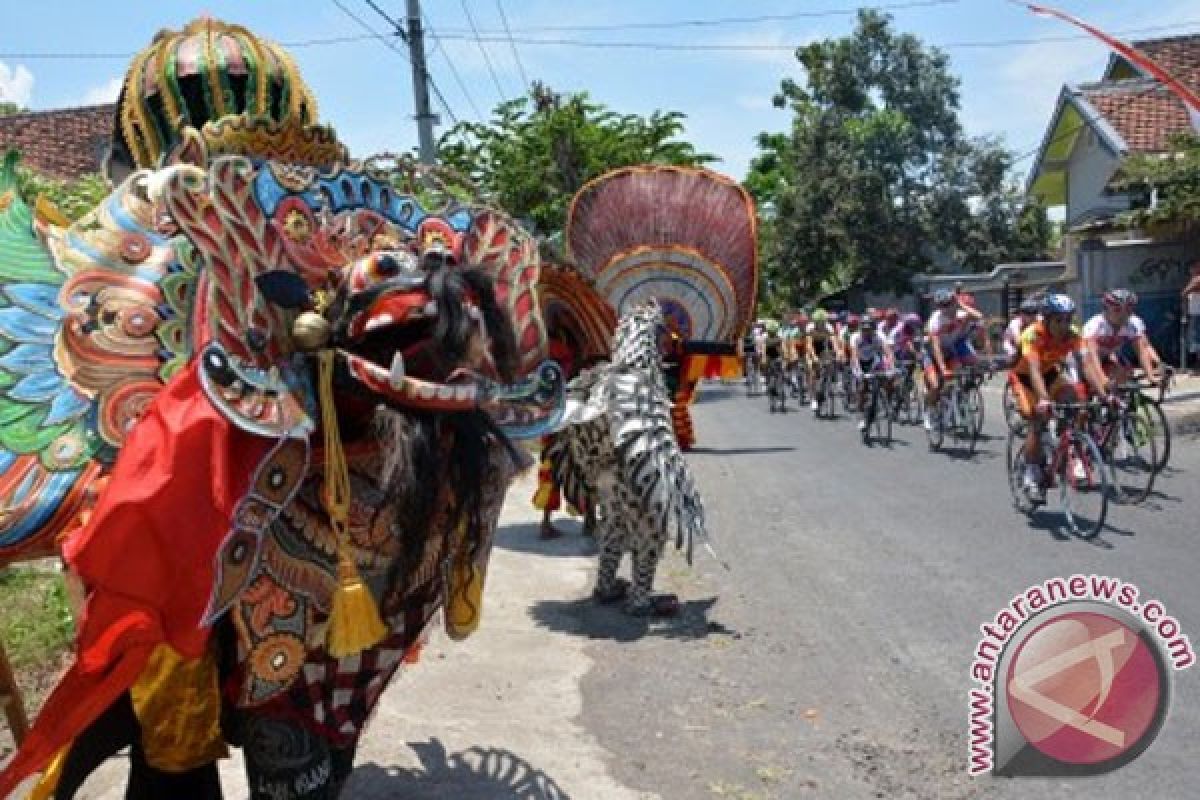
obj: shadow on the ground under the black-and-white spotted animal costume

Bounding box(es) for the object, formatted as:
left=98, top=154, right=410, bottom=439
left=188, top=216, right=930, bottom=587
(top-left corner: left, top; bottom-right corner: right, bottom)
left=529, top=597, right=742, bottom=642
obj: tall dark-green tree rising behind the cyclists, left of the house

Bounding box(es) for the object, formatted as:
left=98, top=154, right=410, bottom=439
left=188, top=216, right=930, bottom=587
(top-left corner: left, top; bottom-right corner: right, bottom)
left=746, top=11, right=1045, bottom=302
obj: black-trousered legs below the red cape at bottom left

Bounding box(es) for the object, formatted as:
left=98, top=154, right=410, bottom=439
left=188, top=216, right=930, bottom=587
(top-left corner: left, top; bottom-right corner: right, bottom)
left=54, top=692, right=222, bottom=800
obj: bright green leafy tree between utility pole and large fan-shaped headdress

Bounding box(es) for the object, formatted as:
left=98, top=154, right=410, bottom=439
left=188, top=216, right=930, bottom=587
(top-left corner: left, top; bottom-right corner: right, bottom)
left=438, top=84, right=715, bottom=234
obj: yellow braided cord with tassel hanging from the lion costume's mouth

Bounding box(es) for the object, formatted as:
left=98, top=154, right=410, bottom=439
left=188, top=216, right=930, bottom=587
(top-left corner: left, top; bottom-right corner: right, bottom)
left=317, top=350, right=388, bottom=658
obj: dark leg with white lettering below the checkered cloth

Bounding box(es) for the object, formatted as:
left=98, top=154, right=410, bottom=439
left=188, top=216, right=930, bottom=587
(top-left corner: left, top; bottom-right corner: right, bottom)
left=242, top=716, right=354, bottom=800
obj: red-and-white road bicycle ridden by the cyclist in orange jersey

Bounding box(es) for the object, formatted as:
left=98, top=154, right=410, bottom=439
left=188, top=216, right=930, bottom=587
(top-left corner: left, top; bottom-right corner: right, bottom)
left=1007, top=403, right=1110, bottom=539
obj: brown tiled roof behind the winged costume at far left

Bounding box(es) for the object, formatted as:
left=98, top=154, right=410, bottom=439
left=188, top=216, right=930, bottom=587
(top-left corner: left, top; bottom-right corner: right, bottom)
left=0, top=103, right=115, bottom=180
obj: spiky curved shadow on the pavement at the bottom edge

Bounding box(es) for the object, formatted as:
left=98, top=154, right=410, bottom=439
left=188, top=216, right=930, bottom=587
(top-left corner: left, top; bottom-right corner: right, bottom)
left=344, top=739, right=570, bottom=800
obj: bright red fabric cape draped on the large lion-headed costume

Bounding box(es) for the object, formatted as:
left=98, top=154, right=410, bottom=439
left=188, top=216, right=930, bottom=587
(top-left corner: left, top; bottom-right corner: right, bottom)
left=0, top=361, right=276, bottom=798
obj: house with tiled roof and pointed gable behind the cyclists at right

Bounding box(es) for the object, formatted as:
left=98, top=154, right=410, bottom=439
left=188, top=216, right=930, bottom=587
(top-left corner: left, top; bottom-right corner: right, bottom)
left=1027, top=35, right=1200, bottom=361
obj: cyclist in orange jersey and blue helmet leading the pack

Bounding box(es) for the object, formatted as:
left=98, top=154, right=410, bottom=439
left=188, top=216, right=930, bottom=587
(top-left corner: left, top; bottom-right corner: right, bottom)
left=1008, top=294, right=1105, bottom=499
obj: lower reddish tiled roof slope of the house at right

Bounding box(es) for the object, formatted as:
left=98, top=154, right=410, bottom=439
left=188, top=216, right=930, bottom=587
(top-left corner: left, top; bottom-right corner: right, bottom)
left=1079, top=79, right=1192, bottom=152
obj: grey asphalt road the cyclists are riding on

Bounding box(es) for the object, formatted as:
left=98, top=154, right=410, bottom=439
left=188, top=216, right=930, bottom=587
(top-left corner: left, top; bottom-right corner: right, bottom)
left=559, top=385, right=1200, bottom=800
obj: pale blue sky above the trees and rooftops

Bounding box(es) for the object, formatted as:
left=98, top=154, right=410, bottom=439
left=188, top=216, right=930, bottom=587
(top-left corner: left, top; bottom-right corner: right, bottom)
left=0, top=0, right=1200, bottom=180
